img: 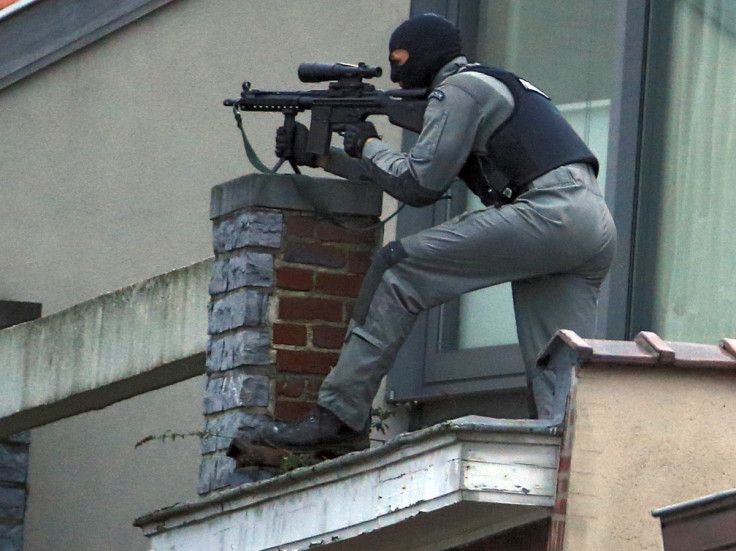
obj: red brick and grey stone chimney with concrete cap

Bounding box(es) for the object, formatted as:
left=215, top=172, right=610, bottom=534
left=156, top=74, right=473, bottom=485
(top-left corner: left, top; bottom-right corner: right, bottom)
left=198, top=174, right=382, bottom=495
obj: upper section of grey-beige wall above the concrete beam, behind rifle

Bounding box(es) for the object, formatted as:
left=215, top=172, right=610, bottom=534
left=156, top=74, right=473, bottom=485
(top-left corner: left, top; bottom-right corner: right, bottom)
left=0, top=0, right=409, bottom=314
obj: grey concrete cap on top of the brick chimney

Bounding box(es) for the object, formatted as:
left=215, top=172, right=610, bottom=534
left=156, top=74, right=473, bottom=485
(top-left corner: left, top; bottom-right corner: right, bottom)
left=210, top=174, right=383, bottom=220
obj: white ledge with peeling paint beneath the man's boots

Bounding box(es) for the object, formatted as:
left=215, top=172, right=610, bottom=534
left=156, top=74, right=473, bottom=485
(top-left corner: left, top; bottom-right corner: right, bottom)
left=135, top=416, right=560, bottom=551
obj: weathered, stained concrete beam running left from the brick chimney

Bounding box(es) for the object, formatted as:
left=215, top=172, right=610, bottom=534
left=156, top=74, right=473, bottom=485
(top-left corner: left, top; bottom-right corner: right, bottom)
left=0, top=259, right=210, bottom=438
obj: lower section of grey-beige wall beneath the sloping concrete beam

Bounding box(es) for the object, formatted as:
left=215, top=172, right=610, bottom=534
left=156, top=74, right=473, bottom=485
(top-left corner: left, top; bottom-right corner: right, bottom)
left=24, top=377, right=204, bottom=551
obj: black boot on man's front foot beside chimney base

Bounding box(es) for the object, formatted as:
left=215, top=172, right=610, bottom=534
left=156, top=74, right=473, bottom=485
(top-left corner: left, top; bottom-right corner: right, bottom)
left=253, top=407, right=369, bottom=457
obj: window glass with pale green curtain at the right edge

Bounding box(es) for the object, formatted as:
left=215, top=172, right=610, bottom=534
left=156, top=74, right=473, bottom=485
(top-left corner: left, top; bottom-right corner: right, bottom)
left=637, top=0, right=736, bottom=342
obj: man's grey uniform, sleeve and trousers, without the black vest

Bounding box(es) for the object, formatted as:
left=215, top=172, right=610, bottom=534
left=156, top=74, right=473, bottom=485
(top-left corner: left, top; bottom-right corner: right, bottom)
left=319, top=57, right=616, bottom=430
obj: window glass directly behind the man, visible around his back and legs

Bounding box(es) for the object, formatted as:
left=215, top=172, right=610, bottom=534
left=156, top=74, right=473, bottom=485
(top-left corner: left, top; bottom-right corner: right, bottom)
left=457, top=0, right=620, bottom=348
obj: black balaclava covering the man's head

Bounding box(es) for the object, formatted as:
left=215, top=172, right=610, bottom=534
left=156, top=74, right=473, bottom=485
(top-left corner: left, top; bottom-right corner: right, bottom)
left=388, top=13, right=463, bottom=88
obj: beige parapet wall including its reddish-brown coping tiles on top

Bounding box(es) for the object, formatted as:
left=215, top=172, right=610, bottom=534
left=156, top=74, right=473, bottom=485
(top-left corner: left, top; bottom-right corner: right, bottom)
left=536, top=331, right=736, bottom=551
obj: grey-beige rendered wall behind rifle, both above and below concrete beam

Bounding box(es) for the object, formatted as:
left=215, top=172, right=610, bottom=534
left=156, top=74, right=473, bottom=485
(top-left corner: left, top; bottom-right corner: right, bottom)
left=0, top=0, right=409, bottom=551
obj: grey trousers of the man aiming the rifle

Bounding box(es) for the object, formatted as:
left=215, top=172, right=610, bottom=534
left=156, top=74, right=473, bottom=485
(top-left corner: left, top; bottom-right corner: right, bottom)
left=319, top=164, right=616, bottom=430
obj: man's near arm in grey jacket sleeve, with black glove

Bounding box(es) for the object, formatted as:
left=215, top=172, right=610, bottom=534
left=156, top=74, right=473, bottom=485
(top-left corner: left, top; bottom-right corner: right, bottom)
left=325, top=57, right=514, bottom=206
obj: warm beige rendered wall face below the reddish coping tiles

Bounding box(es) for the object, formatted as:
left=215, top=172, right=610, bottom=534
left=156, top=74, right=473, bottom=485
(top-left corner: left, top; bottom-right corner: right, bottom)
left=565, top=366, right=736, bottom=551
